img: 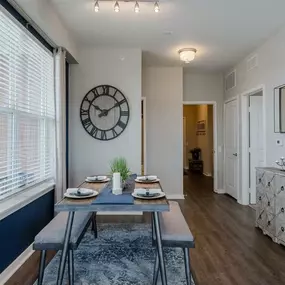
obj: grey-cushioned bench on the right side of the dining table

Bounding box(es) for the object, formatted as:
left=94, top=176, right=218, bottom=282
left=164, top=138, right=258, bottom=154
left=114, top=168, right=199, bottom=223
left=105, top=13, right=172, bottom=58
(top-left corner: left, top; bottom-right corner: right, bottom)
left=153, top=201, right=195, bottom=285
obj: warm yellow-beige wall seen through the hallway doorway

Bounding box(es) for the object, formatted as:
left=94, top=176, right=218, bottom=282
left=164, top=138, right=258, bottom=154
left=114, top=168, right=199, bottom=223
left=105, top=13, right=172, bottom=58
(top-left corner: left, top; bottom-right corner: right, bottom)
left=183, top=105, right=213, bottom=176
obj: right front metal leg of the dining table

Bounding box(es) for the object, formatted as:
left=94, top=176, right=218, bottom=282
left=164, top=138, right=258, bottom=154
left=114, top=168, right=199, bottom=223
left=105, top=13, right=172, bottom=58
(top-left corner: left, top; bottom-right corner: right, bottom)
left=153, top=212, right=167, bottom=285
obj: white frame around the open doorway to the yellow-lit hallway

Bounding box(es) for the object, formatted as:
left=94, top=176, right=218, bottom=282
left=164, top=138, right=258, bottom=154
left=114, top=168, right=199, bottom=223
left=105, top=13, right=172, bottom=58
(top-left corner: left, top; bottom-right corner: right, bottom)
left=181, top=101, right=217, bottom=193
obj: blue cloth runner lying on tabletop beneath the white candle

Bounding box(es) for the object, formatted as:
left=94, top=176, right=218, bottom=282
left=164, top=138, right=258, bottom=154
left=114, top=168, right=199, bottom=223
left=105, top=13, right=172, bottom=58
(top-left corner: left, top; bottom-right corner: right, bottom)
left=92, top=186, right=134, bottom=205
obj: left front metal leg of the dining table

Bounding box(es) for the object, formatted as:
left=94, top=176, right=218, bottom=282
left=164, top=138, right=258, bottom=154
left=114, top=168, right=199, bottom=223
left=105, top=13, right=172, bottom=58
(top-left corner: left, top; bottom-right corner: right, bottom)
left=56, top=212, right=74, bottom=285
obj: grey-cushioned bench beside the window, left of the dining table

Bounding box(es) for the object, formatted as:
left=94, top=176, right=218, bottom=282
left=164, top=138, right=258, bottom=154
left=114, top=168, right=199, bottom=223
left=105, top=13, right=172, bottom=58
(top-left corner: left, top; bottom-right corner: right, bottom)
left=33, top=212, right=97, bottom=285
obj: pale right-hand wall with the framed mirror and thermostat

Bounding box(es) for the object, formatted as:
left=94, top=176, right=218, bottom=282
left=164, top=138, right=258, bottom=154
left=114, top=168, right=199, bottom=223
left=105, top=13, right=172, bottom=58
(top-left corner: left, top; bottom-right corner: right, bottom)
left=225, top=25, right=285, bottom=202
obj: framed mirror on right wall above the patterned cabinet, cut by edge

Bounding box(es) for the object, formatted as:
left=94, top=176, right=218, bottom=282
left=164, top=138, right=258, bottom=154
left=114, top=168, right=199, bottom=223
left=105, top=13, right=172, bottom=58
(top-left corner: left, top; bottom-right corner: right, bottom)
left=274, top=85, right=285, bottom=133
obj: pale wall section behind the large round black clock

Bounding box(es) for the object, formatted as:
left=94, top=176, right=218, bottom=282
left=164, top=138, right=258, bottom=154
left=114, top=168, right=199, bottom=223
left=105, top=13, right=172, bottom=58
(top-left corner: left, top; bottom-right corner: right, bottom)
left=69, top=48, right=142, bottom=186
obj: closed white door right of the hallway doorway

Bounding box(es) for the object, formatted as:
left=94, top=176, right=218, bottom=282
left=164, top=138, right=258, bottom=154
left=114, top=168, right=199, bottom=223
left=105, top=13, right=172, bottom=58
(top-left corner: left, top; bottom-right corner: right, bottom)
left=224, top=100, right=238, bottom=199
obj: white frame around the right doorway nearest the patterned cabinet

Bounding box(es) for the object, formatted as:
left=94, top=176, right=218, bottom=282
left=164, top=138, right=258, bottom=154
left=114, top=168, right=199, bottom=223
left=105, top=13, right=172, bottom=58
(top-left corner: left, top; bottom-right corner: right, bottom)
left=239, top=85, right=266, bottom=205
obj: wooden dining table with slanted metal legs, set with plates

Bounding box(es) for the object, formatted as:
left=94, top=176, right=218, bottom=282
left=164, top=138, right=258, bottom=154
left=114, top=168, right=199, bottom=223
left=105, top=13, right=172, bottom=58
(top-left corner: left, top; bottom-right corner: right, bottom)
left=54, top=182, right=169, bottom=285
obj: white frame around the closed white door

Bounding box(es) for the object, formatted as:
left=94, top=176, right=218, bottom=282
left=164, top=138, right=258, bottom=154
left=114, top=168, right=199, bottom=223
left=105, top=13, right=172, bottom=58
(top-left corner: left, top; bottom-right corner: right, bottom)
left=223, top=96, right=241, bottom=204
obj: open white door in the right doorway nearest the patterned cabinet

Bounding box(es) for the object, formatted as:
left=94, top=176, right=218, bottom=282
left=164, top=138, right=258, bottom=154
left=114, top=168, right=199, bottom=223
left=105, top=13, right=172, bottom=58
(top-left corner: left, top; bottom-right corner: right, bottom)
left=249, top=93, right=264, bottom=204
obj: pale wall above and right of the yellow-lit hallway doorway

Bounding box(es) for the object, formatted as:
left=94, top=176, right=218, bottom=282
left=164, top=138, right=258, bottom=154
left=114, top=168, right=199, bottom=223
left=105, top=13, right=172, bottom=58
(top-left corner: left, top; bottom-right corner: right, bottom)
left=183, top=72, right=224, bottom=192
